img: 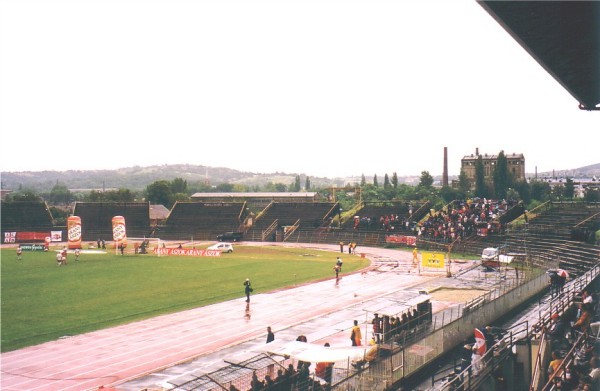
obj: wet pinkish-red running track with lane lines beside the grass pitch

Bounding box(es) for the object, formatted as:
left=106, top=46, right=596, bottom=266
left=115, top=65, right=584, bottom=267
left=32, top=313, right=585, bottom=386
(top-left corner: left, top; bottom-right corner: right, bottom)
left=0, top=246, right=437, bottom=391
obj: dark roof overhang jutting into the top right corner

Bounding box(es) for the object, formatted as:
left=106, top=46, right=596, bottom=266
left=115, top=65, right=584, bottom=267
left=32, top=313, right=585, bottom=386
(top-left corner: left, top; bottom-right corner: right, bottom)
left=478, top=0, right=600, bottom=110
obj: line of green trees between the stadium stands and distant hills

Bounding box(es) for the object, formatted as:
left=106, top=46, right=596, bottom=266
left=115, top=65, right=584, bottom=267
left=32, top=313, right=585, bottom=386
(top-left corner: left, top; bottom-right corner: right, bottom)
left=5, top=151, right=600, bottom=224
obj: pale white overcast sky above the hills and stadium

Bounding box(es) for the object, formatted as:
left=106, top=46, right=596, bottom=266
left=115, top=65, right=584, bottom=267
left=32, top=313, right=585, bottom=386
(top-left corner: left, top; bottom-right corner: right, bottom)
left=0, top=0, right=600, bottom=177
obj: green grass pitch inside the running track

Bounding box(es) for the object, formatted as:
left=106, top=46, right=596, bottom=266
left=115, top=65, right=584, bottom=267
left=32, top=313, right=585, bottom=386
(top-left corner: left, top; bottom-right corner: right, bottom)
left=0, top=245, right=368, bottom=352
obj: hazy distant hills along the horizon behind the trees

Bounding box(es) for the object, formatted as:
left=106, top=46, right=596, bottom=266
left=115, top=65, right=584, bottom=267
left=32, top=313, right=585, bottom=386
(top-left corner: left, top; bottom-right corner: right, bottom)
left=1, top=163, right=600, bottom=193
